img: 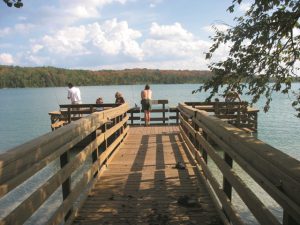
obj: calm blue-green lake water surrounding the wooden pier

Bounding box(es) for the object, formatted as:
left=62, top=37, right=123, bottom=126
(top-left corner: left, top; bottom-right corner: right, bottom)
left=0, top=83, right=300, bottom=224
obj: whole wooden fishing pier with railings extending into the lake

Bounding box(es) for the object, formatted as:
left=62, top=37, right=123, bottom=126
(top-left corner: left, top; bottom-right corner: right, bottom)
left=0, top=100, right=300, bottom=225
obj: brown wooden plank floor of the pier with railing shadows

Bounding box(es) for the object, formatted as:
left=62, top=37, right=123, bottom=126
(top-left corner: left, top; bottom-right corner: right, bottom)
left=73, top=126, right=222, bottom=225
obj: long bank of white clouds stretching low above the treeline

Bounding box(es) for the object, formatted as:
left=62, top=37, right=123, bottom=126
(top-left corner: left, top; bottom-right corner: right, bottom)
left=25, top=19, right=228, bottom=69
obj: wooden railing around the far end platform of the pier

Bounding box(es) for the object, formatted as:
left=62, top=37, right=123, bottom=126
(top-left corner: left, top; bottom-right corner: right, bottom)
left=49, top=100, right=259, bottom=132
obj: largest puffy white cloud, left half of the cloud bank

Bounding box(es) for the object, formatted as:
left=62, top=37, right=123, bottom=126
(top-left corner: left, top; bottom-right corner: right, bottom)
left=32, top=19, right=143, bottom=60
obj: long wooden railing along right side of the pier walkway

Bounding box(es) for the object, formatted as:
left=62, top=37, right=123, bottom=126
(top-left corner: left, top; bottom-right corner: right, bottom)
left=178, top=104, right=300, bottom=225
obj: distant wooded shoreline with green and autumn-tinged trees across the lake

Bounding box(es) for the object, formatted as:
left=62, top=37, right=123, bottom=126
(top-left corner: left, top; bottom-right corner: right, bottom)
left=0, top=66, right=211, bottom=88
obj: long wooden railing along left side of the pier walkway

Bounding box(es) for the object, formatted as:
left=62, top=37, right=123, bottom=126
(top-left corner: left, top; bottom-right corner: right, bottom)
left=0, top=104, right=129, bottom=225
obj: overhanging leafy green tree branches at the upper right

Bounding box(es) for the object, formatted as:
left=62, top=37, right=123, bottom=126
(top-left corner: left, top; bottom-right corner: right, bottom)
left=194, top=0, right=300, bottom=117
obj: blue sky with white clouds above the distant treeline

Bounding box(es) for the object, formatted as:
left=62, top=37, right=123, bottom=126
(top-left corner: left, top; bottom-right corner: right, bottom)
left=0, top=0, right=248, bottom=70
